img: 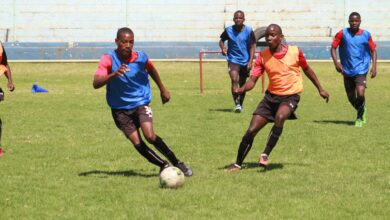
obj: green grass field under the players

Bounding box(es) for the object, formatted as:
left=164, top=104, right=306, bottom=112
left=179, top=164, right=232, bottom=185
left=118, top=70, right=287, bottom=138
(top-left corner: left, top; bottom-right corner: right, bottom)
left=0, top=62, right=390, bottom=219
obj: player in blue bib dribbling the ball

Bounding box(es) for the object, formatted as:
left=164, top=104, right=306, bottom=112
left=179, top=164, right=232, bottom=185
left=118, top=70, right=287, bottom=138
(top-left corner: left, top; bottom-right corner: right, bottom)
left=93, top=27, right=192, bottom=176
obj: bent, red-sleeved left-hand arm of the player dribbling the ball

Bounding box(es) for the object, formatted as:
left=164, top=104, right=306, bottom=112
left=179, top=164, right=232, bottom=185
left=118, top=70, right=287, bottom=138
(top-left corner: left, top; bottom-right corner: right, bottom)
left=92, top=55, right=129, bottom=89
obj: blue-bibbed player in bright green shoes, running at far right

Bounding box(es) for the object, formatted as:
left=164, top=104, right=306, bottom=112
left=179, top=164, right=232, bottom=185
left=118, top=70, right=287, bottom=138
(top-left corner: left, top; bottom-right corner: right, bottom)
left=331, top=12, right=377, bottom=127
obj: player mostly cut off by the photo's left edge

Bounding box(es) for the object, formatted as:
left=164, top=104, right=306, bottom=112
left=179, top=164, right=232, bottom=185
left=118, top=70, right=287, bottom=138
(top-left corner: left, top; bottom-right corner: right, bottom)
left=0, top=41, right=15, bottom=157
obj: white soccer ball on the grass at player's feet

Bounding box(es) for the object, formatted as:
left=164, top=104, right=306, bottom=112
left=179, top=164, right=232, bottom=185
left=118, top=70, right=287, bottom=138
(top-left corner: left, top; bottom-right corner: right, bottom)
left=160, top=167, right=184, bottom=188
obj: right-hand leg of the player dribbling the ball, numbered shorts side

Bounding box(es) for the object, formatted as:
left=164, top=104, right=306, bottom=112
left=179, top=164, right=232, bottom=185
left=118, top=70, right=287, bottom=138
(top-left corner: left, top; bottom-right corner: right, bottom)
left=137, top=106, right=193, bottom=176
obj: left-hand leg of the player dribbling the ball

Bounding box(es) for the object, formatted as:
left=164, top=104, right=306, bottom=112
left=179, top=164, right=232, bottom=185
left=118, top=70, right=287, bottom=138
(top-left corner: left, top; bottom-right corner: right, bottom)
left=111, top=109, right=168, bottom=171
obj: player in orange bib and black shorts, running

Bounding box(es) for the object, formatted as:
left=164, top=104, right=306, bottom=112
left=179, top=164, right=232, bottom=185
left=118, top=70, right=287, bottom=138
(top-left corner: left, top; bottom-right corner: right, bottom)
left=226, top=24, right=329, bottom=172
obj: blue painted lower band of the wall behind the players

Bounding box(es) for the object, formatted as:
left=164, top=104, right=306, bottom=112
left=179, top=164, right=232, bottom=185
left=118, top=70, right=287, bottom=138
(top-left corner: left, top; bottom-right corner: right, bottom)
left=4, top=41, right=390, bottom=60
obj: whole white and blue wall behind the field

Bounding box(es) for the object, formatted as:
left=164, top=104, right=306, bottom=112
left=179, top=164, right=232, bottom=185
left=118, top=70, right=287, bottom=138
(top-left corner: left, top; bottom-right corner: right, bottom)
left=0, top=0, right=390, bottom=59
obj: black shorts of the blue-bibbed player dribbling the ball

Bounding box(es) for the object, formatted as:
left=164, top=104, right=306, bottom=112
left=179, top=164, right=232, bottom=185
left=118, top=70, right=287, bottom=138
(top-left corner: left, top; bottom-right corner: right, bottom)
left=111, top=105, right=153, bottom=137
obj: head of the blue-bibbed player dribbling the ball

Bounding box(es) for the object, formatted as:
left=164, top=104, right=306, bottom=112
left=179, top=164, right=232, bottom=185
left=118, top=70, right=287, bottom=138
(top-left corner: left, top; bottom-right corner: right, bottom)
left=115, top=27, right=134, bottom=58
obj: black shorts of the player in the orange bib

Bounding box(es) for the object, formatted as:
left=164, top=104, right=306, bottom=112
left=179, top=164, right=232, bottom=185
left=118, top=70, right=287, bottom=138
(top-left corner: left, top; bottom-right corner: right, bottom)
left=253, top=91, right=300, bottom=121
